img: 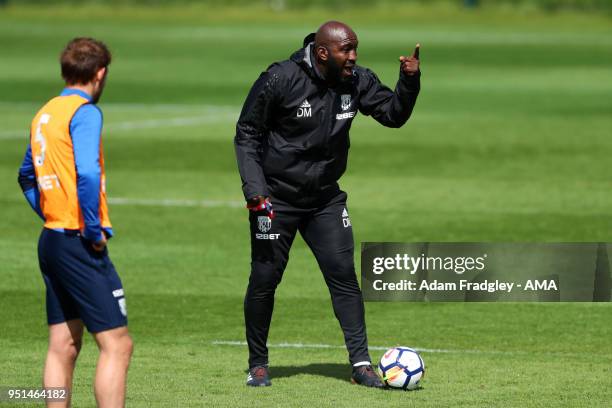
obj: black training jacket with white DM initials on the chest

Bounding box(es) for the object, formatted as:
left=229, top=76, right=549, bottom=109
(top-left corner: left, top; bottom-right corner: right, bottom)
left=234, top=38, right=420, bottom=207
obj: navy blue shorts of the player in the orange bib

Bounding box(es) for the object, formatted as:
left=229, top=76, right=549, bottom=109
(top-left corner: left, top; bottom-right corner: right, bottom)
left=38, top=228, right=127, bottom=333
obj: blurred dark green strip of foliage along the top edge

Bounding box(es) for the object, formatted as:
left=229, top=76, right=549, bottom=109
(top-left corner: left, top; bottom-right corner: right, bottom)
left=0, top=0, right=612, bottom=12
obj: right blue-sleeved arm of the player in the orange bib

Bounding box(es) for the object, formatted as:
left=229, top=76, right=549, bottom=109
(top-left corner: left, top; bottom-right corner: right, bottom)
left=70, top=104, right=106, bottom=245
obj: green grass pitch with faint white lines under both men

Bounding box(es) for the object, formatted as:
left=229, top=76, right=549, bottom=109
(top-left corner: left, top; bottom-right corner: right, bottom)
left=0, top=3, right=612, bottom=407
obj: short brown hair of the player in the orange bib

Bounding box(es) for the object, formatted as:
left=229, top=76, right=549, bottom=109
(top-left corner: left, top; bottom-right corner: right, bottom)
left=60, top=38, right=111, bottom=85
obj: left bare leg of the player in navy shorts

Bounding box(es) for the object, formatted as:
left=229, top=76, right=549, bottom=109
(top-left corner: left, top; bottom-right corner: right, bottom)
left=43, top=319, right=83, bottom=408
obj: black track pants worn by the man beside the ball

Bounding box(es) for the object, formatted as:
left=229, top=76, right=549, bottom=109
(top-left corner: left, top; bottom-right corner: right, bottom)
left=244, top=192, right=370, bottom=367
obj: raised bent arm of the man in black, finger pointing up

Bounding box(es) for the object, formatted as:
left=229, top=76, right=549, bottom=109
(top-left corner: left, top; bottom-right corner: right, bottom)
left=359, top=45, right=421, bottom=128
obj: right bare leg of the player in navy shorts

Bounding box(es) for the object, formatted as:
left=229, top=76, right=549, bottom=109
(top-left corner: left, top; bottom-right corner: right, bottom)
left=94, top=326, right=133, bottom=408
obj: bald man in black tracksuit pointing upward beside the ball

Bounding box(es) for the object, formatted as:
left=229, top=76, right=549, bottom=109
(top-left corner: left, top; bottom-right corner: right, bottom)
left=234, top=21, right=420, bottom=387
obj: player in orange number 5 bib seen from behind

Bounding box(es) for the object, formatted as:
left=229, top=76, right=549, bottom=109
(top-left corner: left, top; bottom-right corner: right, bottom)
left=19, top=38, right=133, bottom=407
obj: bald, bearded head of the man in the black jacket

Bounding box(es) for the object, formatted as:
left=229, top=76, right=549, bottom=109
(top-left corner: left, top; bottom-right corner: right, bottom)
left=314, top=21, right=358, bottom=85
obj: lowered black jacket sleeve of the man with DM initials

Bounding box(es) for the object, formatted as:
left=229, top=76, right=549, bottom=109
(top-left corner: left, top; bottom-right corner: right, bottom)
left=234, top=66, right=281, bottom=203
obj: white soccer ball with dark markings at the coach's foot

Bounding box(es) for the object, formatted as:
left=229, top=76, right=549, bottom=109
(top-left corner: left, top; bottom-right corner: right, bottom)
left=378, top=347, right=425, bottom=390
